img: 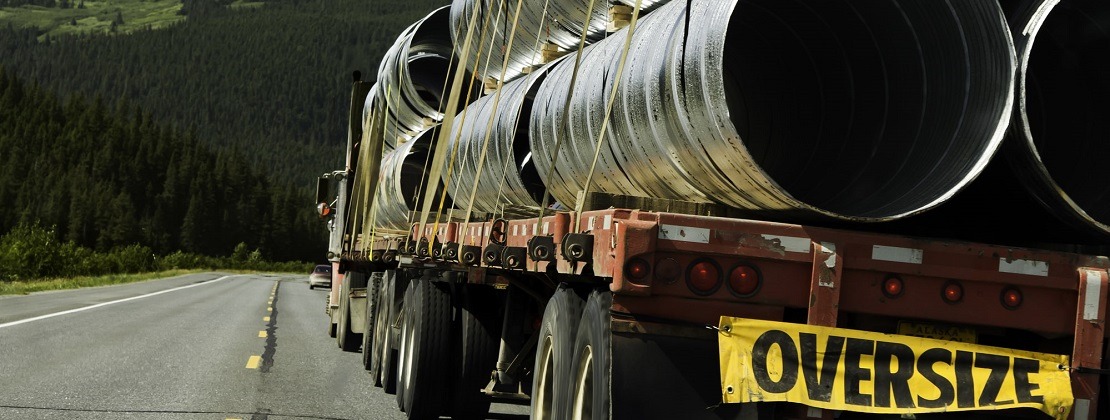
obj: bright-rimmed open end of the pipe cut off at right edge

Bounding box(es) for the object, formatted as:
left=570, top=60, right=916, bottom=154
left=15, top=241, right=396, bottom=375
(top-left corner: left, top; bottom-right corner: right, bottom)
left=1003, top=0, right=1110, bottom=238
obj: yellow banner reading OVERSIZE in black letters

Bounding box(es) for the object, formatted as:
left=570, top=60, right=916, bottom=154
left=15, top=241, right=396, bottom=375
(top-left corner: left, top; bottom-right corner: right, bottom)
left=718, top=317, right=1072, bottom=420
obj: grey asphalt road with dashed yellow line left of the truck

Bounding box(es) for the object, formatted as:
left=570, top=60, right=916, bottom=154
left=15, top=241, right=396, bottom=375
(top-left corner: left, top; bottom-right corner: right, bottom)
left=0, top=273, right=527, bottom=420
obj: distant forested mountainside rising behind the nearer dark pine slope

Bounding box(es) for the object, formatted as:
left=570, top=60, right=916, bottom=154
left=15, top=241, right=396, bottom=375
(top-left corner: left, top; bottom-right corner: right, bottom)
left=0, top=0, right=442, bottom=188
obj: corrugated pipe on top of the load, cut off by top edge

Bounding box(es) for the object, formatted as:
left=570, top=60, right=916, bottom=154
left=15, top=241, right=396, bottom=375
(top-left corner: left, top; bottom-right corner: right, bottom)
left=451, top=0, right=668, bottom=81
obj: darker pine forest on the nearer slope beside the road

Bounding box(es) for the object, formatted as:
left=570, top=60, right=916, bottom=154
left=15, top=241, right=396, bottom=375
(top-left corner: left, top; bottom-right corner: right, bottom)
left=0, top=67, right=325, bottom=260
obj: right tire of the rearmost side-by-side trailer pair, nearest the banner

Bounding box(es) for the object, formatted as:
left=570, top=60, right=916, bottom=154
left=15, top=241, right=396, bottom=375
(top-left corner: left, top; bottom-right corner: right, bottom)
left=567, top=290, right=613, bottom=420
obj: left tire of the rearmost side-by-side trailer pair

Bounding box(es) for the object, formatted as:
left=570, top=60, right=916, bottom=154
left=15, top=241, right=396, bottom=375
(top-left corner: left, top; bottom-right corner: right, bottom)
left=532, top=283, right=583, bottom=420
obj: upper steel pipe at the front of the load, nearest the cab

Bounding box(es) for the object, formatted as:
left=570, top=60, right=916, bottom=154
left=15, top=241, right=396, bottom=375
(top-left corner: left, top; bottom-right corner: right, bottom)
left=364, top=7, right=454, bottom=149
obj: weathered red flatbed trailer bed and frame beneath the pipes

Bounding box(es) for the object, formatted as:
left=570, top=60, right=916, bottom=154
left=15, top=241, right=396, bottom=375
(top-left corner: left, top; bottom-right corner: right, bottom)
left=333, top=209, right=1110, bottom=419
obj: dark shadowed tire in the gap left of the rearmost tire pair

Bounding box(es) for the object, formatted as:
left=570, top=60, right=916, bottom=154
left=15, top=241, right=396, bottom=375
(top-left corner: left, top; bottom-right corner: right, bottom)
left=451, top=284, right=502, bottom=420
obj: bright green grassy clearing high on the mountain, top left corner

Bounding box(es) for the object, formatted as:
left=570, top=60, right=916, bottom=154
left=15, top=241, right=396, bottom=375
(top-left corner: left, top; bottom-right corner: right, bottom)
left=0, top=0, right=185, bottom=37
